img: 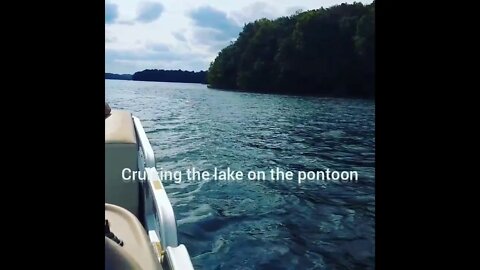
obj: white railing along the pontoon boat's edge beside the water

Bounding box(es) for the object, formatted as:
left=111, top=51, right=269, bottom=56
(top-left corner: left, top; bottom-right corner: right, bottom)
left=133, top=116, right=193, bottom=270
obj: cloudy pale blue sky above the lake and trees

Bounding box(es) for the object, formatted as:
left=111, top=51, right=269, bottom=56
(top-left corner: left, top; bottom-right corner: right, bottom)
left=105, top=0, right=372, bottom=74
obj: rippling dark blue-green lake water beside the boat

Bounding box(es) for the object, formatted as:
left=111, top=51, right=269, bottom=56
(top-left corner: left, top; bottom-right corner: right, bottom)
left=105, top=80, right=375, bottom=269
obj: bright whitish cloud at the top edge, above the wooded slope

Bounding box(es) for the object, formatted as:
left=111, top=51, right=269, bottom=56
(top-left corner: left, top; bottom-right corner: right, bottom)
left=232, top=2, right=281, bottom=25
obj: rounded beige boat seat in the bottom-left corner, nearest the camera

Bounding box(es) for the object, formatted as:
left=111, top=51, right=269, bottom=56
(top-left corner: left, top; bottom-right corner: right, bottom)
left=105, top=203, right=162, bottom=270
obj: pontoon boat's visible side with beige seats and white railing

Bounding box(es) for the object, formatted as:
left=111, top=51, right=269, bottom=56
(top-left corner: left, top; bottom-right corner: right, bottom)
left=105, top=110, right=193, bottom=270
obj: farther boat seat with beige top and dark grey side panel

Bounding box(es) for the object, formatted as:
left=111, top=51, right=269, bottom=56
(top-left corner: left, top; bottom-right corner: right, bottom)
left=105, top=110, right=140, bottom=217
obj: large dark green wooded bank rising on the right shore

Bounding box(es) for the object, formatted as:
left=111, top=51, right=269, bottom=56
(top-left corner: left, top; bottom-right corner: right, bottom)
left=207, top=2, right=375, bottom=98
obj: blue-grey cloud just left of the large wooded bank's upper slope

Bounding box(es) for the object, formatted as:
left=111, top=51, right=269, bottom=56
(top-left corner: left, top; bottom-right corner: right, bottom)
left=189, top=6, right=242, bottom=51
